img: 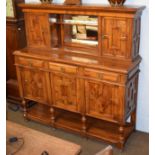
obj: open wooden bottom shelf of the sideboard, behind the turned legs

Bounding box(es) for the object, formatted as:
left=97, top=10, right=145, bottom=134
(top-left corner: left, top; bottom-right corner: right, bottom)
left=27, top=103, right=134, bottom=147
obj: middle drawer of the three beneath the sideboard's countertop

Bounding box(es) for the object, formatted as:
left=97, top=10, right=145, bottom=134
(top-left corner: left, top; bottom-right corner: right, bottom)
left=49, top=62, right=77, bottom=74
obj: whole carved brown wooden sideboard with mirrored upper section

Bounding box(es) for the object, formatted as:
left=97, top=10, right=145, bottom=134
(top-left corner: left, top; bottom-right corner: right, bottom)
left=14, top=4, right=145, bottom=148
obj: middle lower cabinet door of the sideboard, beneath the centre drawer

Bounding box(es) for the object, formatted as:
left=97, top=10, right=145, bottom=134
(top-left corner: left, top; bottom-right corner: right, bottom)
left=51, top=73, right=80, bottom=112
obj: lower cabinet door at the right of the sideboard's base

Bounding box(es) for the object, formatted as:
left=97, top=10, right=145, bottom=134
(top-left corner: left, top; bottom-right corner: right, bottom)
left=85, top=80, right=123, bottom=121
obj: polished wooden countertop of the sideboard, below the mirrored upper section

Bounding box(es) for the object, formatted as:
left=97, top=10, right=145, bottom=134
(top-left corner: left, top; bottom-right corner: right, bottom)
left=14, top=48, right=141, bottom=74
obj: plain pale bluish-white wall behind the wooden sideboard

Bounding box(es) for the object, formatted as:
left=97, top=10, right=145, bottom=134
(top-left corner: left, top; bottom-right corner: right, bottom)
left=25, top=0, right=149, bottom=132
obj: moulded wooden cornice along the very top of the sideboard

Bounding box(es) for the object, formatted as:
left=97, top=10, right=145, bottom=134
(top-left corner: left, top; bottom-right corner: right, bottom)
left=19, top=3, right=145, bottom=14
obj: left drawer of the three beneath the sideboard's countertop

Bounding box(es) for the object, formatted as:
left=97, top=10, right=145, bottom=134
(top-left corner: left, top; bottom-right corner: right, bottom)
left=17, top=57, right=44, bottom=68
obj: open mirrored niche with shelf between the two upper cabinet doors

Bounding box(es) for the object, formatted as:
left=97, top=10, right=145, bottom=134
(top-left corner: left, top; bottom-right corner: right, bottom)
left=49, top=14, right=99, bottom=55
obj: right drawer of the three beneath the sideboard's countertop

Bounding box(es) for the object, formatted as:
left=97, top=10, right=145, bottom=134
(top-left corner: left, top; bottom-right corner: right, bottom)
left=84, top=69, right=120, bottom=82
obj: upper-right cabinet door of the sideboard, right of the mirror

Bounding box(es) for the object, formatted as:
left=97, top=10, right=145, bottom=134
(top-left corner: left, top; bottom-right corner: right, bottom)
left=102, top=17, right=132, bottom=58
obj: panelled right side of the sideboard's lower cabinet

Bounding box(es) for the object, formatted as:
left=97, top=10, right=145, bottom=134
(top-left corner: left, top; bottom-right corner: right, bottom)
left=125, top=74, right=138, bottom=118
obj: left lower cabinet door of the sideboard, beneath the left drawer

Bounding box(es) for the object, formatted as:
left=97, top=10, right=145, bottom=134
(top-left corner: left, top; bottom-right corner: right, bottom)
left=20, top=68, right=48, bottom=104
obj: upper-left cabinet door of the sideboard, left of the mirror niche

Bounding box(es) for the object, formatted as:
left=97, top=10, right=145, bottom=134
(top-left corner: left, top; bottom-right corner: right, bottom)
left=25, top=13, right=51, bottom=48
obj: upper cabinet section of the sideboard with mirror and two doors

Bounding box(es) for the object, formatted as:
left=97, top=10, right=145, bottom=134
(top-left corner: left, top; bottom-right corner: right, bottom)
left=20, top=4, right=144, bottom=62
